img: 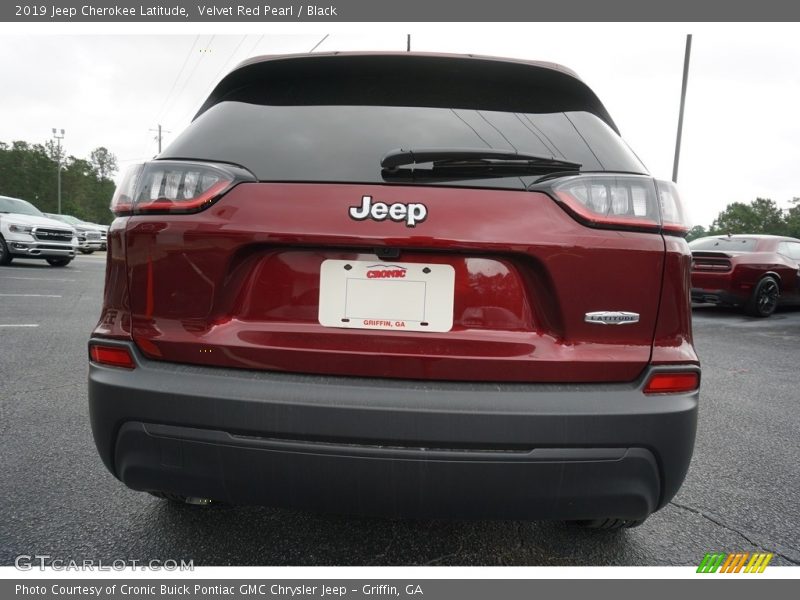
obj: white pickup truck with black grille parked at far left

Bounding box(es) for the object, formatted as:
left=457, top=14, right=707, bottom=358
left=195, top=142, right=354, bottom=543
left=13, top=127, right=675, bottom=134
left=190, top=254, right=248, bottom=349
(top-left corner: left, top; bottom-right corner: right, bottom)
left=0, top=196, right=78, bottom=267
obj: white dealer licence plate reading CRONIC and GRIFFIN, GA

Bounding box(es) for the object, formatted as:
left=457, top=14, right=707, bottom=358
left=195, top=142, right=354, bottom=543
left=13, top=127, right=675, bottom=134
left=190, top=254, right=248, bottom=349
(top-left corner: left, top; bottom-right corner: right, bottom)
left=319, top=260, right=455, bottom=331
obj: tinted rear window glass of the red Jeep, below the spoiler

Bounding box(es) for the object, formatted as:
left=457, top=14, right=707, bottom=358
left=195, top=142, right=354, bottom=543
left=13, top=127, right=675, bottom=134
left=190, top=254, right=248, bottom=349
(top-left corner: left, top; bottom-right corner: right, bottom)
left=162, top=101, right=646, bottom=187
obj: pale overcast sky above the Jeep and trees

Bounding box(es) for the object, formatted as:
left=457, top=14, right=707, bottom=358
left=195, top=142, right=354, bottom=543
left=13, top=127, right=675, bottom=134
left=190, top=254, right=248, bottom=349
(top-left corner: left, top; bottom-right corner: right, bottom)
left=0, top=23, right=800, bottom=225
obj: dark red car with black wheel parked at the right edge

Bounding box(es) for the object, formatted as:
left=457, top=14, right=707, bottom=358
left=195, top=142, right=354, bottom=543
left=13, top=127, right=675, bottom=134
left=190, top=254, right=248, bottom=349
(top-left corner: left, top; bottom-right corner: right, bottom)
left=689, top=235, right=800, bottom=317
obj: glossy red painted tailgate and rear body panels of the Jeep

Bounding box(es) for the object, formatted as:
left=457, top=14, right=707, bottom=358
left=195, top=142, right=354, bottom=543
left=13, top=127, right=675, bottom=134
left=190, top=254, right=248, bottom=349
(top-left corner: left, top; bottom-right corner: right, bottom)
left=95, top=183, right=697, bottom=382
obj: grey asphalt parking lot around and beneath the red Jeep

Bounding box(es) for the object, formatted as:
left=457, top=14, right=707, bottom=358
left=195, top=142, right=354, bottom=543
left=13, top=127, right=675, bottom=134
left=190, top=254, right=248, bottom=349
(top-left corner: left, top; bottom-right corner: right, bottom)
left=0, top=253, right=800, bottom=565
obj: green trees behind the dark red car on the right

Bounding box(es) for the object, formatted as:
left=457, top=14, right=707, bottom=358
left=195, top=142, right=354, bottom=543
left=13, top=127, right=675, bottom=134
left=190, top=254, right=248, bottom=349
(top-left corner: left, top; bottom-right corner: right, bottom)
left=686, top=198, right=800, bottom=241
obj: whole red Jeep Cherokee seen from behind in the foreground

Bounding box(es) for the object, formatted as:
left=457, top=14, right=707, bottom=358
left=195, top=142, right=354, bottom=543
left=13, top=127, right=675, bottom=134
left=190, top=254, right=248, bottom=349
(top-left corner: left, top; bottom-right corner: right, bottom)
left=89, top=53, right=700, bottom=528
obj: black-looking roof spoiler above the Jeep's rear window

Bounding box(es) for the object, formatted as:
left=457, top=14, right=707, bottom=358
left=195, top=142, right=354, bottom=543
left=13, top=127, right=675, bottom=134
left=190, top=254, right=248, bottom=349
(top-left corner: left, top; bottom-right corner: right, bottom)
left=194, top=52, right=619, bottom=134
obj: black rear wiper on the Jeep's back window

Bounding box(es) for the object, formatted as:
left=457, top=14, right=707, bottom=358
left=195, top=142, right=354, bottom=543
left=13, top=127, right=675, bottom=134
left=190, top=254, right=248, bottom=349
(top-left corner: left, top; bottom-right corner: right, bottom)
left=381, top=148, right=581, bottom=172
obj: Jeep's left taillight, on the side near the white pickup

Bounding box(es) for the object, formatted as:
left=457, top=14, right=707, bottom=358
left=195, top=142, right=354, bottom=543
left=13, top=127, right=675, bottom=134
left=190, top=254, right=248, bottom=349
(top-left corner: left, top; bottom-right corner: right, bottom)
left=111, top=160, right=255, bottom=215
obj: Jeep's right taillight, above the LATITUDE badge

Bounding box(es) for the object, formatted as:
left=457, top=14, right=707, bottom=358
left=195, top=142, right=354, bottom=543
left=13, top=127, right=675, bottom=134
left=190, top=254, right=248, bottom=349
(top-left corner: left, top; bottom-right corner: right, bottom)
left=548, top=173, right=689, bottom=235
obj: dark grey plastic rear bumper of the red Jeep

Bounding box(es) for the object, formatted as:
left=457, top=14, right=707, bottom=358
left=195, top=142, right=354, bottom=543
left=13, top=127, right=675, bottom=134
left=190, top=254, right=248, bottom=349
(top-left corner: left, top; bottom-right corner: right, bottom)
left=89, top=338, right=698, bottom=519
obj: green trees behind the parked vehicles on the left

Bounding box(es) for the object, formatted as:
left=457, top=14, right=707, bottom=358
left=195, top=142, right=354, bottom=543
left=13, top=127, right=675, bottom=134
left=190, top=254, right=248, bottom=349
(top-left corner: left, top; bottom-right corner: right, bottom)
left=0, top=141, right=117, bottom=225
